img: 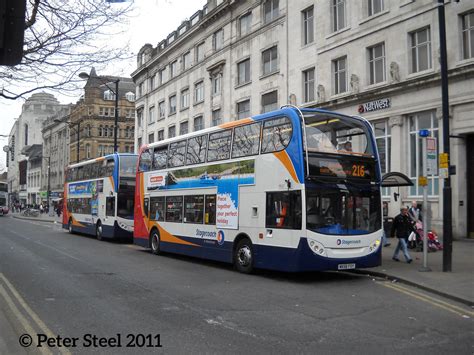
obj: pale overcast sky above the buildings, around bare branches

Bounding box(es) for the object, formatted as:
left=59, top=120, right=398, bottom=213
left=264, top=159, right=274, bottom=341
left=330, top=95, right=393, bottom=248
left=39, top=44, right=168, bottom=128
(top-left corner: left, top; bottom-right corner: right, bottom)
left=0, top=0, right=207, bottom=169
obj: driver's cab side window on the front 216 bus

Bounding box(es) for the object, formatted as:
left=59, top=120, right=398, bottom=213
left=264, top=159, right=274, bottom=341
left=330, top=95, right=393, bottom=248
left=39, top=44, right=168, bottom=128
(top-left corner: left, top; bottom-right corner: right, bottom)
left=265, top=191, right=302, bottom=229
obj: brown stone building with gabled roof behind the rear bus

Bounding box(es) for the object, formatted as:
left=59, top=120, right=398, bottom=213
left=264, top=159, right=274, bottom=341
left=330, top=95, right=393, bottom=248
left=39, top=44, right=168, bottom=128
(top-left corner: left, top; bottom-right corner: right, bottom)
left=67, top=69, right=135, bottom=163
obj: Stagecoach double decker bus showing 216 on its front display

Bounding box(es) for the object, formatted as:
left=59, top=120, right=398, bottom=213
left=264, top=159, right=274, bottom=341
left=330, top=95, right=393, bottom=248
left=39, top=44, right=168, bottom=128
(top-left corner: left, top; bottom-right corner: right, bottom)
left=134, top=106, right=383, bottom=273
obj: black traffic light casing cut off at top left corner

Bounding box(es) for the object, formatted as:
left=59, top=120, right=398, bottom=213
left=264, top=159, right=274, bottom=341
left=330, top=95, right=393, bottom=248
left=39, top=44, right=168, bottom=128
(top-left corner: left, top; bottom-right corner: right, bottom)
left=0, top=0, right=26, bottom=65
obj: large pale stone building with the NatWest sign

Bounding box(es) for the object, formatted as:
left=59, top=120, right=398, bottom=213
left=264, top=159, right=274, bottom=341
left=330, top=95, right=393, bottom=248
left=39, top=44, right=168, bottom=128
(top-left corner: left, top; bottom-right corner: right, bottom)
left=132, top=0, right=474, bottom=237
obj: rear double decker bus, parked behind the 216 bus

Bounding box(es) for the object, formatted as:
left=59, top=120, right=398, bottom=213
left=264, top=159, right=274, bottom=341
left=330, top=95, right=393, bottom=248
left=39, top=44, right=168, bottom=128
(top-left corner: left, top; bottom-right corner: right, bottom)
left=63, top=153, right=137, bottom=240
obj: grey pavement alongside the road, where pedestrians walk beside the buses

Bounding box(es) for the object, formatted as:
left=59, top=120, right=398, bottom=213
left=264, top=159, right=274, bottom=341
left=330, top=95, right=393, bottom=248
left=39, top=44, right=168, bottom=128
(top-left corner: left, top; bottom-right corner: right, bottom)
left=8, top=213, right=474, bottom=307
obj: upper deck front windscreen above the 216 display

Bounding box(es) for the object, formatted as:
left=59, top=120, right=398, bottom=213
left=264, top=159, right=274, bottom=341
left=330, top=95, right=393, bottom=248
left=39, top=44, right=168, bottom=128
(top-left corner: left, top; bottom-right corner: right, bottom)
left=304, top=112, right=374, bottom=156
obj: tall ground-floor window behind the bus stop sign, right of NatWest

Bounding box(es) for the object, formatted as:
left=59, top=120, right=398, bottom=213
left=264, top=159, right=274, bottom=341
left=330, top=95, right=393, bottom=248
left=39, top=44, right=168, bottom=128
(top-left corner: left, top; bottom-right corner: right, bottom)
left=408, top=111, right=439, bottom=196
